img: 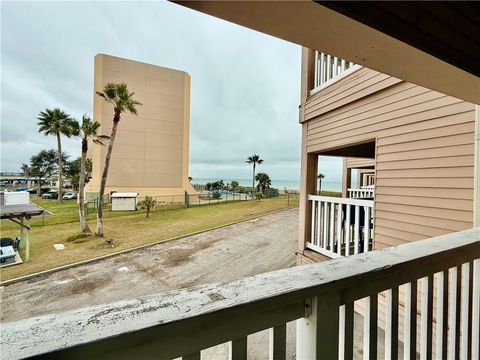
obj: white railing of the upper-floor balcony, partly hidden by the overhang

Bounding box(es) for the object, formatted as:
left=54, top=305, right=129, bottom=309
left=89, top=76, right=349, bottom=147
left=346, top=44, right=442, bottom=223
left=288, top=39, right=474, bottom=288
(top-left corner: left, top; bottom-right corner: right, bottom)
left=313, top=51, right=354, bottom=91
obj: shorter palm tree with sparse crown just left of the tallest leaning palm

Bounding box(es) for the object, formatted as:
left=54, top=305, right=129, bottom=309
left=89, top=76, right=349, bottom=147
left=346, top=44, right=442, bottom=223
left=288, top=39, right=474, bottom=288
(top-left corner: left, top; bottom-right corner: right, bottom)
left=77, top=114, right=110, bottom=233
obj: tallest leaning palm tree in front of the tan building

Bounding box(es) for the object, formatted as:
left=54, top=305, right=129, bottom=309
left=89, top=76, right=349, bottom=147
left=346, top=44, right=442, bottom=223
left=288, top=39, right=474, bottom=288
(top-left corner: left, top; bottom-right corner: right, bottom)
left=95, top=83, right=142, bottom=236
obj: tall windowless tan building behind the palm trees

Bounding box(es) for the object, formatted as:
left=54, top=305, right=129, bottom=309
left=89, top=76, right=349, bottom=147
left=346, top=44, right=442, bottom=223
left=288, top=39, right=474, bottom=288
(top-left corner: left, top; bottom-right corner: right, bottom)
left=86, top=54, right=195, bottom=199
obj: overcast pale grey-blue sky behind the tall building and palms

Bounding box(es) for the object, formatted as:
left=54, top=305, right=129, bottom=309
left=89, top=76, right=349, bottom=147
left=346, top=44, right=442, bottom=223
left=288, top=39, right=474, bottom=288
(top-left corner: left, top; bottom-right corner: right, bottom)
left=1, top=1, right=340, bottom=181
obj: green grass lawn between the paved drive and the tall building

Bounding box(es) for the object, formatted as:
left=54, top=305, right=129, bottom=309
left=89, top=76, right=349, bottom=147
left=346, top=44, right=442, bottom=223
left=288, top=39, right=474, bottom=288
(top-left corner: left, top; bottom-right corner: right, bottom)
left=0, top=197, right=298, bottom=281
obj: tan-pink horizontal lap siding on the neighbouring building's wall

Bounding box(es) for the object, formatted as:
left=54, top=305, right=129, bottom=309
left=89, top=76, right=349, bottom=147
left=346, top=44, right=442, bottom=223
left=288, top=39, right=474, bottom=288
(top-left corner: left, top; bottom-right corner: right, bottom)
left=300, top=68, right=475, bottom=248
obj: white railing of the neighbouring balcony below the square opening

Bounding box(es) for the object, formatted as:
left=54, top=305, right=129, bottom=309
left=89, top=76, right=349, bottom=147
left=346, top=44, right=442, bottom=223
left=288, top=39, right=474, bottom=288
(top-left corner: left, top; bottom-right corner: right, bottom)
left=307, top=195, right=373, bottom=258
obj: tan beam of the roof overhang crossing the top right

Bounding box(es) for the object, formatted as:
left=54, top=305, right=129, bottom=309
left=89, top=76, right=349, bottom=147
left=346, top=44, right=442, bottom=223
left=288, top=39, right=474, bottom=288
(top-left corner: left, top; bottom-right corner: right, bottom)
left=175, top=1, right=480, bottom=104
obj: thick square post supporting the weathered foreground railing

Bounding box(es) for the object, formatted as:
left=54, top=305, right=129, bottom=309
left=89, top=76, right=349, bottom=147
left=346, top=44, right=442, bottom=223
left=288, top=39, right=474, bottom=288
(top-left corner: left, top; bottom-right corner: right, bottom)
left=296, top=293, right=342, bottom=359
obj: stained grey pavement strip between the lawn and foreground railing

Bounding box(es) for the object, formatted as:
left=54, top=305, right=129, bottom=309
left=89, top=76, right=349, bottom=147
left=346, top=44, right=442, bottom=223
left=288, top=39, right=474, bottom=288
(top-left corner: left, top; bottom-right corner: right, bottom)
left=0, top=209, right=298, bottom=322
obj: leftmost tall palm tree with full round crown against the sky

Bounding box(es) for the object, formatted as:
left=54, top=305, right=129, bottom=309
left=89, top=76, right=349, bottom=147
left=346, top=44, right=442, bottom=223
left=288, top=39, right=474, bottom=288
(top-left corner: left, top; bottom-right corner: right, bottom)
left=38, top=108, right=76, bottom=203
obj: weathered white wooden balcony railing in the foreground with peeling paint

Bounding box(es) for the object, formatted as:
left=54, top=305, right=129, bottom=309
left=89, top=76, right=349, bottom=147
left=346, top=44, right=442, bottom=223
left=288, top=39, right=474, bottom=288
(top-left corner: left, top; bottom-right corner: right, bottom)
left=0, top=228, right=480, bottom=360
